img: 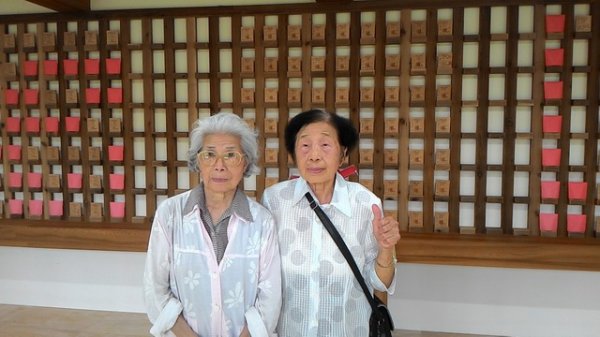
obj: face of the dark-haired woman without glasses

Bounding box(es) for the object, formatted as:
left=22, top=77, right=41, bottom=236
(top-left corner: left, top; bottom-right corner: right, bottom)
left=295, top=122, right=342, bottom=185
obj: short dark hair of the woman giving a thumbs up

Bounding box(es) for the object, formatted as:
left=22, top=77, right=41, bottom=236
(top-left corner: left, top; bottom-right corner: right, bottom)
left=285, top=109, right=358, bottom=160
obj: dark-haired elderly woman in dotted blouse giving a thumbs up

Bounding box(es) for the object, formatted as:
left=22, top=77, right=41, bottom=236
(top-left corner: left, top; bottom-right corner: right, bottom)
left=262, top=110, right=400, bottom=337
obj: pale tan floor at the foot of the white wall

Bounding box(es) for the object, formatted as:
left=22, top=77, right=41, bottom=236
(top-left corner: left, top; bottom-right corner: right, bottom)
left=0, top=304, right=496, bottom=337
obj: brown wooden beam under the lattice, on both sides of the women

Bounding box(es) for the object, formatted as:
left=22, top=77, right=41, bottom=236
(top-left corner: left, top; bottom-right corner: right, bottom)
left=0, top=219, right=600, bottom=271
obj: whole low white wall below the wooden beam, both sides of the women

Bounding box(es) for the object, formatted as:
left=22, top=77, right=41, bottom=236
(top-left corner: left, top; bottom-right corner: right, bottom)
left=0, top=247, right=600, bottom=337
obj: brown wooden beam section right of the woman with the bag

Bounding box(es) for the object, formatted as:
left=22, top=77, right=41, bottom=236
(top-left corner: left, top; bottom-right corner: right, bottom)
left=396, top=233, right=600, bottom=271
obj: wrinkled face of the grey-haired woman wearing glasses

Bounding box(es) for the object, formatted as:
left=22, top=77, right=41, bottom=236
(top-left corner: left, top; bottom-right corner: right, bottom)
left=198, top=134, right=246, bottom=193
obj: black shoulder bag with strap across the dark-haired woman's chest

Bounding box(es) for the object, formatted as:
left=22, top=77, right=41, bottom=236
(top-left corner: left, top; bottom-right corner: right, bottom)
left=304, top=192, right=394, bottom=337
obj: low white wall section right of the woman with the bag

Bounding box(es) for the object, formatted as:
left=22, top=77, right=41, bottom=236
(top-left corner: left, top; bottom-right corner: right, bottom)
left=390, top=264, right=600, bottom=337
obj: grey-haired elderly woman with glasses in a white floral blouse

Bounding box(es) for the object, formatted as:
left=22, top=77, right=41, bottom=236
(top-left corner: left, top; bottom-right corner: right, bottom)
left=144, top=113, right=281, bottom=337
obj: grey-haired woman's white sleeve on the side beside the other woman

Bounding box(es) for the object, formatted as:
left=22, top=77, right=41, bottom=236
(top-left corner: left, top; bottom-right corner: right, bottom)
left=245, top=209, right=281, bottom=337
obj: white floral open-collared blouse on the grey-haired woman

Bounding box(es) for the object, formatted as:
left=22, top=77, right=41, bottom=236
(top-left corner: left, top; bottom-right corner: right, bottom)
left=144, top=186, right=281, bottom=337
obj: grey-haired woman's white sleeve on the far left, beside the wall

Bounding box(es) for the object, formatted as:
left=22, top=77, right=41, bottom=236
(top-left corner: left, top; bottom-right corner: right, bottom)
left=144, top=207, right=183, bottom=337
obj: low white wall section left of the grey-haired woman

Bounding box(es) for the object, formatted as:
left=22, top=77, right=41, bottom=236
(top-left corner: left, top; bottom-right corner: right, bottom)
left=0, top=247, right=146, bottom=312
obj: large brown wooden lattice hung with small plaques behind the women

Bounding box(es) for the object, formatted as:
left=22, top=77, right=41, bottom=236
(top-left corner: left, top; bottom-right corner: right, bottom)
left=0, top=0, right=600, bottom=270
